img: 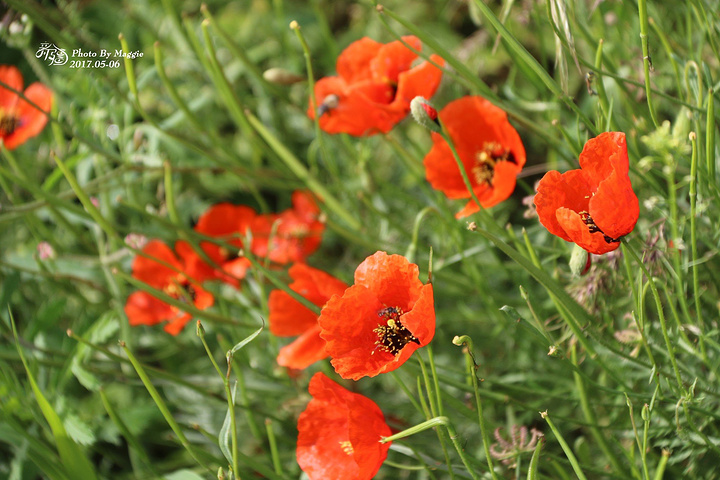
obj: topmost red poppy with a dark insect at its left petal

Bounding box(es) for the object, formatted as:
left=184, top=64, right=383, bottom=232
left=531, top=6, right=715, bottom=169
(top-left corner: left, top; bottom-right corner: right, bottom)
left=308, top=36, right=444, bottom=136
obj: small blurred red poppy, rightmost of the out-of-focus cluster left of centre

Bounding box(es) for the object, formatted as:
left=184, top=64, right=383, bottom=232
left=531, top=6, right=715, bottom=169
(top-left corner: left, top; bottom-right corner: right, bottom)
left=251, top=191, right=325, bottom=264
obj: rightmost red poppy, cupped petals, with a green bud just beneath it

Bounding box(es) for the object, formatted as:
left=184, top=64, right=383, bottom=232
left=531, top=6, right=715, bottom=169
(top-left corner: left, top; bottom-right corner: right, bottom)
left=535, top=132, right=640, bottom=255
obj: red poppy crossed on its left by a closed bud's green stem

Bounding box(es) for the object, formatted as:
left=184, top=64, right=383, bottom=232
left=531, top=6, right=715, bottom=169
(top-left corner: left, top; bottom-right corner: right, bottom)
left=423, top=97, right=525, bottom=218
